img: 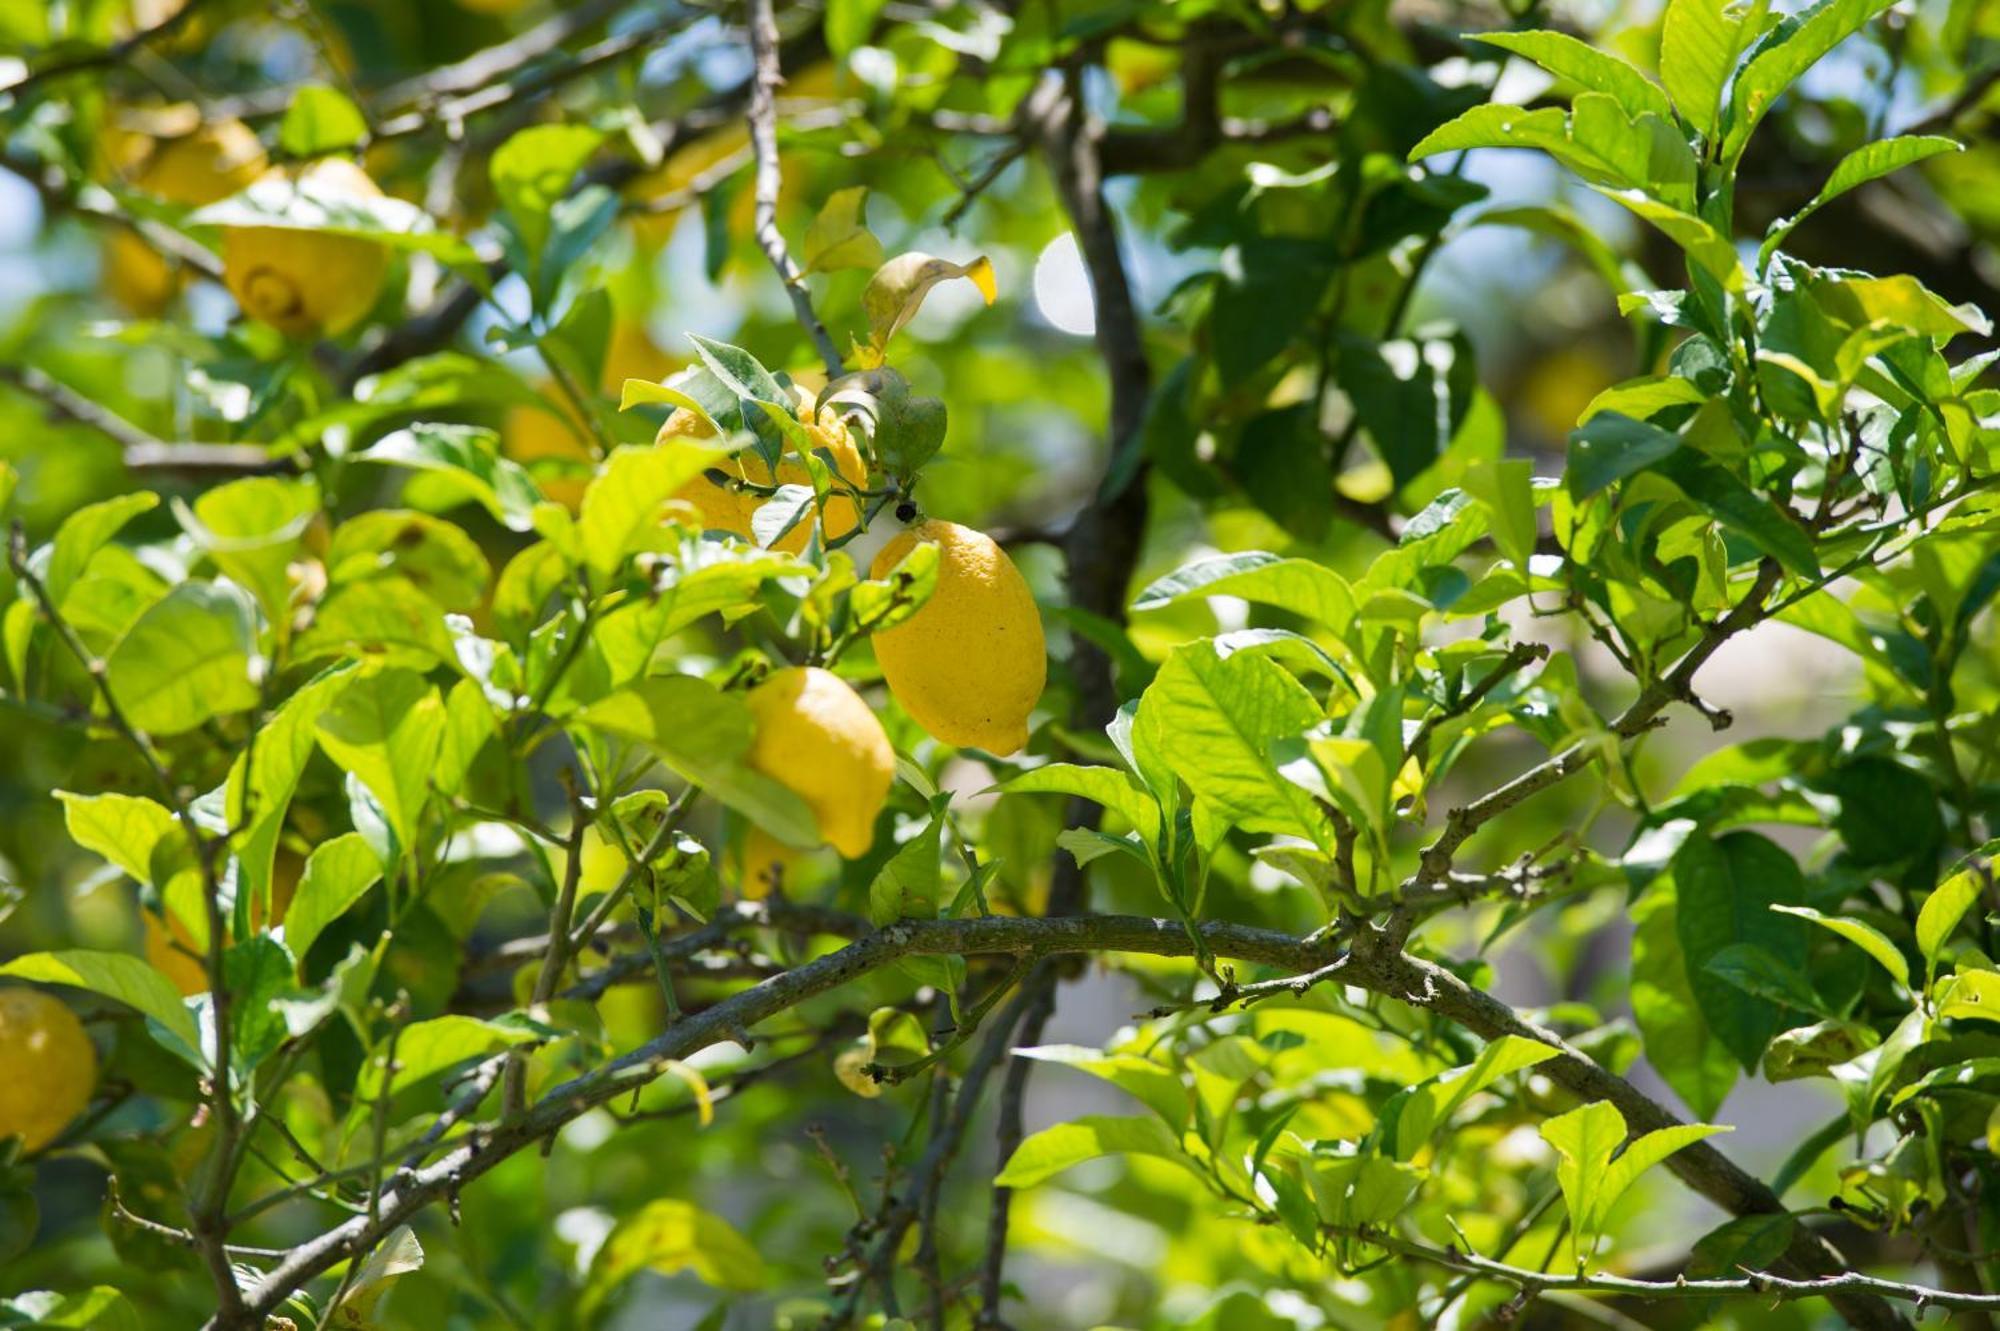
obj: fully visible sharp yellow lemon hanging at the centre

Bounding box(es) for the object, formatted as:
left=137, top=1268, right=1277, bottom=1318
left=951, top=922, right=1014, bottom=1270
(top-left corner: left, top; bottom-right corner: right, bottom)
left=872, top=520, right=1048, bottom=757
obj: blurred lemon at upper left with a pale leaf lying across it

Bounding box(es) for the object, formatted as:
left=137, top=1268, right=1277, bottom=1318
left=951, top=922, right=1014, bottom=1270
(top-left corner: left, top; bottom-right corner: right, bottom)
left=222, top=158, right=388, bottom=338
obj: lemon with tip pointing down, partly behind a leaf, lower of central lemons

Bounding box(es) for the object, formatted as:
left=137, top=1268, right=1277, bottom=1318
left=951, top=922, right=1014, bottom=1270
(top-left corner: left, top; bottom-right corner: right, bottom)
left=748, top=666, right=896, bottom=859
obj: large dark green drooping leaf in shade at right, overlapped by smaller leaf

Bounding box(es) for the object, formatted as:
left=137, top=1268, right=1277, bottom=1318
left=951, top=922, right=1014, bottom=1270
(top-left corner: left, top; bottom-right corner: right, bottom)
left=1674, top=831, right=1806, bottom=1071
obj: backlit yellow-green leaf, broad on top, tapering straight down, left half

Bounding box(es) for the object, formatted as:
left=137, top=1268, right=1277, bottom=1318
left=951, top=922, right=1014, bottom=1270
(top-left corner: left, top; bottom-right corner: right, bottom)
left=318, top=669, right=444, bottom=853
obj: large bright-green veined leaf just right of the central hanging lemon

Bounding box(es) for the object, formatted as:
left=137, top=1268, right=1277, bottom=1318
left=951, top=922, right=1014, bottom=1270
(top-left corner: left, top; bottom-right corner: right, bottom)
left=1144, top=642, right=1332, bottom=847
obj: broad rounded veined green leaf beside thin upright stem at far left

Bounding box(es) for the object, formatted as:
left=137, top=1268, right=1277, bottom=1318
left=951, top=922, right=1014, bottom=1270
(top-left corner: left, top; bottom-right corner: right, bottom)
left=104, top=582, right=264, bottom=735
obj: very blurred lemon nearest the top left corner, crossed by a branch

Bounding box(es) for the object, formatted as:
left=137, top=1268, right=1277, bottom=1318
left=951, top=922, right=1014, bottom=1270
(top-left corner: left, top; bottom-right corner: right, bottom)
left=104, top=120, right=264, bottom=314
